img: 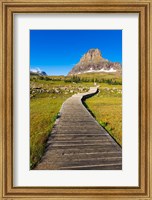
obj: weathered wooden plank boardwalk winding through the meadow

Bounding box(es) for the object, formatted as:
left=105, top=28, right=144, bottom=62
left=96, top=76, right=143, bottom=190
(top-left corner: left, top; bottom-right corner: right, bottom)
left=35, top=87, right=122, bottom=170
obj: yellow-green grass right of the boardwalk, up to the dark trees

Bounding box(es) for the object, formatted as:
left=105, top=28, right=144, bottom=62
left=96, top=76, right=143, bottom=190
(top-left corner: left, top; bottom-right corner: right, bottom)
left=86, top=84, right=122, bottom=145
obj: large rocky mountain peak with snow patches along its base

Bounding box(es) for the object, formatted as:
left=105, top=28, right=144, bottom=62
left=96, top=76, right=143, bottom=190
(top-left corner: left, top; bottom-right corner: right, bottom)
left=68, top=49, right=122, bottom=75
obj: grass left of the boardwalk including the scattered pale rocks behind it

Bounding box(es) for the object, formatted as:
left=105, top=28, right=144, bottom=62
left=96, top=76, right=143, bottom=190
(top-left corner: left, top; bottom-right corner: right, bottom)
left=30, top=77, right=91, bottom=169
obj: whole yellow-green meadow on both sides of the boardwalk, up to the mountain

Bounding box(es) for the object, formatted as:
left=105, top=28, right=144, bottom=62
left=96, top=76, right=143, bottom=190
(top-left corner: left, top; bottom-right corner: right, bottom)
left=30, top=73, right=122, bottom=169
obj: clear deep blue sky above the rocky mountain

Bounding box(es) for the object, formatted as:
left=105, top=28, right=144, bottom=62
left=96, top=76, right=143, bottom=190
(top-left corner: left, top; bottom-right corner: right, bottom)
left=30, top=30, right=122, bottom=75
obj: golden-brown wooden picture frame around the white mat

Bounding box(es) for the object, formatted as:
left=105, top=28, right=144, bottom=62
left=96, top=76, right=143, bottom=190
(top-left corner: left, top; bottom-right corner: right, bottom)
left=0, top=0, right=152, bottom=200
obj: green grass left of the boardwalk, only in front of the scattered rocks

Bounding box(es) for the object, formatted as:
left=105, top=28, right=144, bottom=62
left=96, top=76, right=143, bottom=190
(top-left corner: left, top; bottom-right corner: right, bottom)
left=30, top=94, right=69, bottom=169
